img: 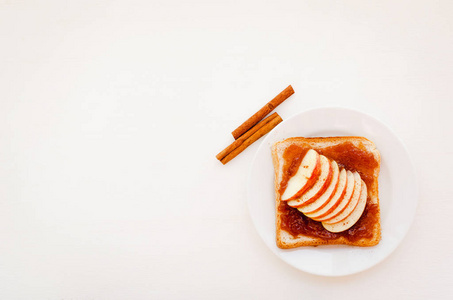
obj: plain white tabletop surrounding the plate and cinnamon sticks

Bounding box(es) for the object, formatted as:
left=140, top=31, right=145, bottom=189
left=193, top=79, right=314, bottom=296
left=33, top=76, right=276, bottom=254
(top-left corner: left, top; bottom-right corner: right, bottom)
left=0, top=0, right=453, bottom=299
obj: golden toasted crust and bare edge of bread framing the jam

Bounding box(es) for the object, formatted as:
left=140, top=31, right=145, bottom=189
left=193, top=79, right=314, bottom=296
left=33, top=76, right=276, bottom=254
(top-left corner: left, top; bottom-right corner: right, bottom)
left=271, top=136, right=381, bottom=249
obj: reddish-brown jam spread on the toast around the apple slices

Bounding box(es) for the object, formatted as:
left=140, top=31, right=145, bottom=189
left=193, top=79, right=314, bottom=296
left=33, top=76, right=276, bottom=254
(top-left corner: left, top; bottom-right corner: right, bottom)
left=278, top=142, right=379, bottom=242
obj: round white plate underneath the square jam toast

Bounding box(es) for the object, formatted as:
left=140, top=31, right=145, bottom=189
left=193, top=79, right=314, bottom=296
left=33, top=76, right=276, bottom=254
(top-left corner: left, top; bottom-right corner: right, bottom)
left=247, top=108, right=418, bottom=276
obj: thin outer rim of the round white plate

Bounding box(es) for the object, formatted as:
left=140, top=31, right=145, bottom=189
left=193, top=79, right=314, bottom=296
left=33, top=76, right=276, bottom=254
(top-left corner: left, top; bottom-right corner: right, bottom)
left=246, top=106, right=419, bottom=277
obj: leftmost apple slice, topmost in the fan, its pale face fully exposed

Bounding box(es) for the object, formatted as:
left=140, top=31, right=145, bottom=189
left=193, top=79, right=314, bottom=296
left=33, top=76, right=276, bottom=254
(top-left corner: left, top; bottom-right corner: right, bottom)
left=281, top=149, right=321, bottom=201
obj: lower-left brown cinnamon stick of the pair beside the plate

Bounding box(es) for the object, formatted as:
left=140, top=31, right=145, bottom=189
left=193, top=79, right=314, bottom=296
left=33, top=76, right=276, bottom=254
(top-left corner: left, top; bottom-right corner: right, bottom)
left=216, top=113, right=283, bottom=164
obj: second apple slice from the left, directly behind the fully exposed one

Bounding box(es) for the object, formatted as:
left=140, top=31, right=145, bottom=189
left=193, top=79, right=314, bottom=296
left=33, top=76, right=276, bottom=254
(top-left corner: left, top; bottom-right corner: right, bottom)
left=288, top=155, right=332, bottom=207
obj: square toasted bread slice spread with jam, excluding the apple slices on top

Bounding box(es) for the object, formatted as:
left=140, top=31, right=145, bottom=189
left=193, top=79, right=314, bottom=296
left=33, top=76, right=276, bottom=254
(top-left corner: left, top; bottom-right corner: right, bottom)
left=272, top=136, right=381, bottom=249
